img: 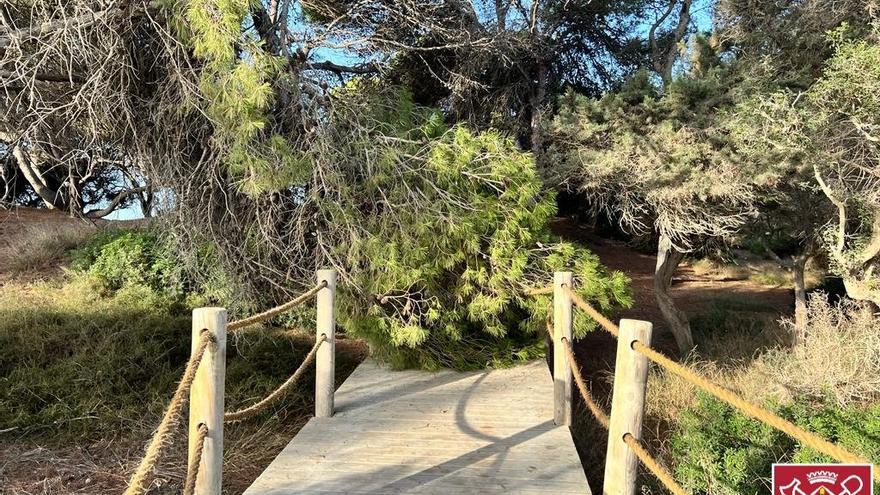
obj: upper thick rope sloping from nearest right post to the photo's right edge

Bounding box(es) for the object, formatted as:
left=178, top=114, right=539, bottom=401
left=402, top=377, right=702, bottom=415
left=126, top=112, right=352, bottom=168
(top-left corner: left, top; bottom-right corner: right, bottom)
left=630, top=340, right=880, bottom=478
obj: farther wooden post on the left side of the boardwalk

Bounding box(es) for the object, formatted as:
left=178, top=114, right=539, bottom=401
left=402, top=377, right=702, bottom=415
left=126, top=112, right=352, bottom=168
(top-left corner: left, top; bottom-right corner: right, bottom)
left=315, top=270, right=336, bottom=418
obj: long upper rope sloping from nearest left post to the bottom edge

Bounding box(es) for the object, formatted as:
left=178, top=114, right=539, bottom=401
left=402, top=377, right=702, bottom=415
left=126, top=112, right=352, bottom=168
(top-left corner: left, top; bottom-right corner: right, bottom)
left=124, top=330, right=214, bottom=495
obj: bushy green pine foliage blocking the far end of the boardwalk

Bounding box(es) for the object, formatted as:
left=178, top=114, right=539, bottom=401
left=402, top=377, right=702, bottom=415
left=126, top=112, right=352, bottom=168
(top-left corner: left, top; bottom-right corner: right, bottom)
left=313, top=89, right=631, bottom=369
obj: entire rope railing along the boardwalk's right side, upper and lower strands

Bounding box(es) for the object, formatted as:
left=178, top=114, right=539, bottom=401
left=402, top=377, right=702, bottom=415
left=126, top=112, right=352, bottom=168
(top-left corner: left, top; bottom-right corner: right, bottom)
left=548, top=285, right=880, bottom=494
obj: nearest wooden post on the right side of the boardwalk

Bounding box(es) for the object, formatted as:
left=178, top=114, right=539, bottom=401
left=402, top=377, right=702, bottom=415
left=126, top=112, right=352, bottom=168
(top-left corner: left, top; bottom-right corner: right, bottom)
left=603, top=320, right=651, bottom=495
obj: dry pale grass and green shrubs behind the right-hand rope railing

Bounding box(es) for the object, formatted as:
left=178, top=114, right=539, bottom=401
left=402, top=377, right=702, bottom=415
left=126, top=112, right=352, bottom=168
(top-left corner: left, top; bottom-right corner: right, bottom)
left=645, top=292, right=880, bottom=495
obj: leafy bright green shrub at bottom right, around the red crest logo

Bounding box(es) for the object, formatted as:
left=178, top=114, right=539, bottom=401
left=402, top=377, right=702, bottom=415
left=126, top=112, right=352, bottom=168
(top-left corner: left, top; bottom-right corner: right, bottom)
left=670, top=394, right=880, bottom=495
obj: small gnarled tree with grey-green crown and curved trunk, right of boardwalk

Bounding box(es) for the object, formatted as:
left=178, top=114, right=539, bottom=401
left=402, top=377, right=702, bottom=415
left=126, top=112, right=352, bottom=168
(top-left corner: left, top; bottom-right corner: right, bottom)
left=552, top=68, right=757, bottom=352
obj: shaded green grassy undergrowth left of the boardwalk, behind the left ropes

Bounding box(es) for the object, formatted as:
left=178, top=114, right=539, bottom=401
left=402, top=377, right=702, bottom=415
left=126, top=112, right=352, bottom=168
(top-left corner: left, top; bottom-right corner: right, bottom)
left=0, top=231, right=359, bottom=444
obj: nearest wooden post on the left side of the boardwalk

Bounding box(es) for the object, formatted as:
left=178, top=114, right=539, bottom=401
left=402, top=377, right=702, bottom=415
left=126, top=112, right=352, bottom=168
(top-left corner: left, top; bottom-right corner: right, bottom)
left=189, top=308, right=226, bottom=495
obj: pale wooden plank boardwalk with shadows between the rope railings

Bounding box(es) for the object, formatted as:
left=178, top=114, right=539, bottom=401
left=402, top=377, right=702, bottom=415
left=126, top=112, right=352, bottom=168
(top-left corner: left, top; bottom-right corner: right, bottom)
left=245, top=360, right=590, bottom=495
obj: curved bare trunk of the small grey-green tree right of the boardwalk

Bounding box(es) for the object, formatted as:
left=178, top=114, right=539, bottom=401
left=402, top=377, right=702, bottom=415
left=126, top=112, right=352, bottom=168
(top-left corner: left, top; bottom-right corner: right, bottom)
left=654, top=234, right=694, bottom=354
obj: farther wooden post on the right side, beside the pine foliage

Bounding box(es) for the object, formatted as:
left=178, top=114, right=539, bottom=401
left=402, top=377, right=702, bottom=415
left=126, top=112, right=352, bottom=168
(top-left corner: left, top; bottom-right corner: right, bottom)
left=553, top=272, right=572, bottom=426
